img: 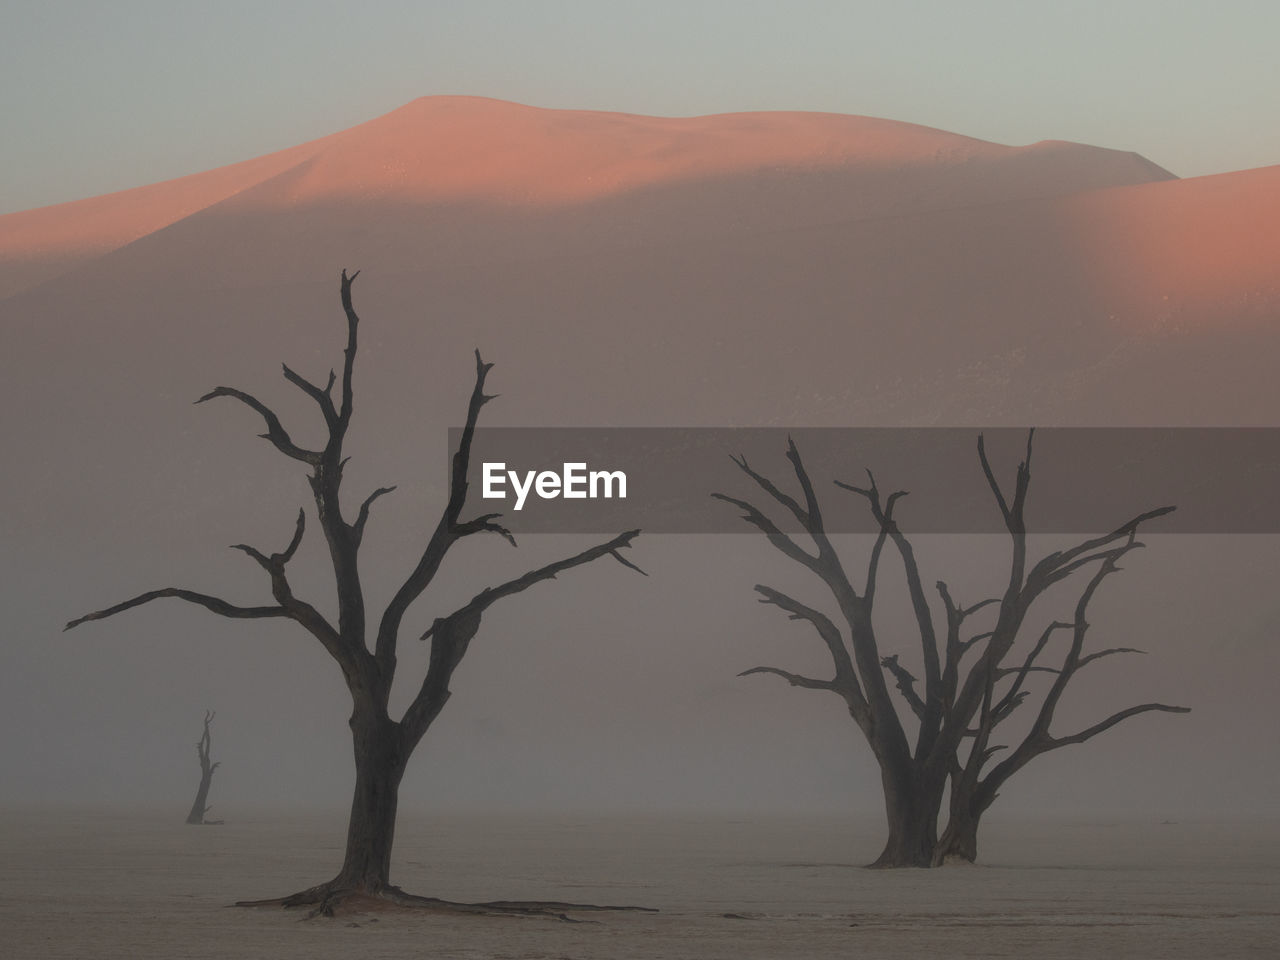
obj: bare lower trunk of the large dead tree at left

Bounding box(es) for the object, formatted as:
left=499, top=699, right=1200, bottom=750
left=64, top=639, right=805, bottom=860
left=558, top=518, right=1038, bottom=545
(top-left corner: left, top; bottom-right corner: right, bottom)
left=329, top=710, right=408, bottom=893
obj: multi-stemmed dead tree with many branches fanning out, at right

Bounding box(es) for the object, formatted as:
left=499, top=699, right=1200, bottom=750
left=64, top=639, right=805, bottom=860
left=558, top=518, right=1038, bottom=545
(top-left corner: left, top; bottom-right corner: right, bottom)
left=713, top=434, right=1185, bottom=867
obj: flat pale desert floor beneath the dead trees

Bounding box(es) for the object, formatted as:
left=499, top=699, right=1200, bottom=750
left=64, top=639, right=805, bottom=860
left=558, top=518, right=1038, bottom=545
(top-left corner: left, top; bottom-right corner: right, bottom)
left=0, top=812, right=1280, bottom=960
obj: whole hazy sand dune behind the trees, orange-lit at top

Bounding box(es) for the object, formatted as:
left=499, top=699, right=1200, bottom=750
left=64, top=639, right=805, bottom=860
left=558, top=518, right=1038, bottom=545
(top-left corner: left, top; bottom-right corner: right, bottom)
left=0, top=97, right=1280, bottom=817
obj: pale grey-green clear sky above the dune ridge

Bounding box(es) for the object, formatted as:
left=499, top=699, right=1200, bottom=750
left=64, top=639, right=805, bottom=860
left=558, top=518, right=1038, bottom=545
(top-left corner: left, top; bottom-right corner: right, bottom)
left=0, top=0, right=1280, bottom=212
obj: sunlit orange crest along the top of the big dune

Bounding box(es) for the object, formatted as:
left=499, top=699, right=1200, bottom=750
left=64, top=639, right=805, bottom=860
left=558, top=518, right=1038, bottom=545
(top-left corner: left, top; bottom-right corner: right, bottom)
left=0, top=97, right=1170, bottom=294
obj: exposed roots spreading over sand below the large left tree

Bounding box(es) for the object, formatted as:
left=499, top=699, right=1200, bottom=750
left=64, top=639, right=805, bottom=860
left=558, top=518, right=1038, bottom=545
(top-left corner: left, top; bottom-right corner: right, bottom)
left=236, top=882, right=658, bottom=923
